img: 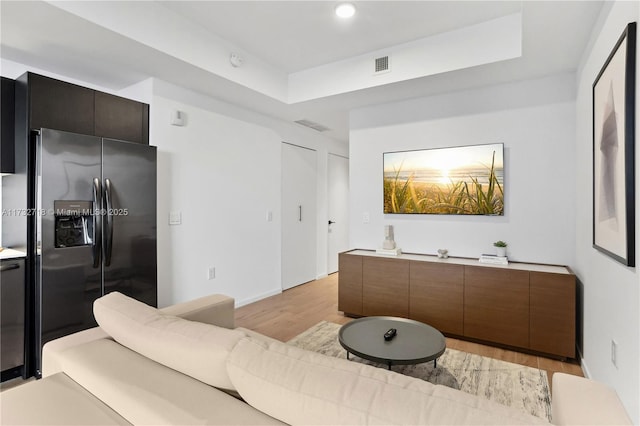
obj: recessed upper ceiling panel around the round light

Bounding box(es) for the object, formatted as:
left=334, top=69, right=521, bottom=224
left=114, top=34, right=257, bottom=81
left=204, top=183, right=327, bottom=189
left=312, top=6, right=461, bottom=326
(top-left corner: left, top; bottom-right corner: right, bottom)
left=161, top=1, right=522, bottom=72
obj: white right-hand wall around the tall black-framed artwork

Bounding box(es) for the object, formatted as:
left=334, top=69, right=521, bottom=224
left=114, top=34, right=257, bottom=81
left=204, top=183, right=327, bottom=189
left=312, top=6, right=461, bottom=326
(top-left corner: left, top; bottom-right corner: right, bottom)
left=574, top=2, right=640, bottom=424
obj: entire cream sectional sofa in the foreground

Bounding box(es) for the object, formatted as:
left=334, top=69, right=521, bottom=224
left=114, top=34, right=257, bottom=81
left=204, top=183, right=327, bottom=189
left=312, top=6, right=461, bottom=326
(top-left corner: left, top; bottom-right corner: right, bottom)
left=0, top=293, right=630, bottom=425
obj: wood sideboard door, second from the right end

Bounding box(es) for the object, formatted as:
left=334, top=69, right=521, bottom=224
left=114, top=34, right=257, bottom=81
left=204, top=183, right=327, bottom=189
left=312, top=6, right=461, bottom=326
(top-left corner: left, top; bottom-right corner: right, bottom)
left=464, top=266, right=529, bottom=348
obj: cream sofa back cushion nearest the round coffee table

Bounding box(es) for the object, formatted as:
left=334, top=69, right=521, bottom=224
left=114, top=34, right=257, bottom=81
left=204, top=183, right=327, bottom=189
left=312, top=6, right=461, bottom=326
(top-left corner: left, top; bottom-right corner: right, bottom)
left=227, top=337, right=547, bottom=425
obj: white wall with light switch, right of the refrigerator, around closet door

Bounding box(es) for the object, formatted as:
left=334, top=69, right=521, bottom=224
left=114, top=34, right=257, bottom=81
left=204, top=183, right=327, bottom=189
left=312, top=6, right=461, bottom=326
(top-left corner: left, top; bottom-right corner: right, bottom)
left=150, top=80, right=347, bottom=306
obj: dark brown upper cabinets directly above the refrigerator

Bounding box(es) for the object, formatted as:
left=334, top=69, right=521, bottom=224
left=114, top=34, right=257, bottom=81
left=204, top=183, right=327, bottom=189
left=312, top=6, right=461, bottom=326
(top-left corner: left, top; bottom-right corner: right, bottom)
left=17, top=73, right=149, bottom=145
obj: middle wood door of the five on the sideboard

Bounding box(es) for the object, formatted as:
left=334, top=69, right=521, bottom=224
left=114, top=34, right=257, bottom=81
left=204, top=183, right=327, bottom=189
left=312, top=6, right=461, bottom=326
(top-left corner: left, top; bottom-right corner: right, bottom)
left=409, top=261, right=464, bottom=336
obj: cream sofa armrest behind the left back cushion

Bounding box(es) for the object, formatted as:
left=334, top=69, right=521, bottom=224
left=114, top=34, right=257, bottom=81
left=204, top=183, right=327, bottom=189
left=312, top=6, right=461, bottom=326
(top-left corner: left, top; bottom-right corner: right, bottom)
left=160, top=294, right=235, bottom=329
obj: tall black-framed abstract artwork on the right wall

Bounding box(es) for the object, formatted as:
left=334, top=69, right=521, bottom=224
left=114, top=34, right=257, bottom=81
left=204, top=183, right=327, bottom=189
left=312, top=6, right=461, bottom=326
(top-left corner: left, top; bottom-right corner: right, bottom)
left=593, top=22, right=636, bottom=266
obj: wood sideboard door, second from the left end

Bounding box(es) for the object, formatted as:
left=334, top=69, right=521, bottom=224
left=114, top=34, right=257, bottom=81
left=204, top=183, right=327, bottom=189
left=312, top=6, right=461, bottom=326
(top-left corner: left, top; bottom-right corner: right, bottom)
left=362, top=257, right=409, bottom=318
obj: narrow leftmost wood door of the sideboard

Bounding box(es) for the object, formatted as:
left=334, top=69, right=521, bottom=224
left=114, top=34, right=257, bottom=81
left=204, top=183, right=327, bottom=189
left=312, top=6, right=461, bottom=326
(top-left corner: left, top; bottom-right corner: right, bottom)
left=338, top=253, right=362, bottom=316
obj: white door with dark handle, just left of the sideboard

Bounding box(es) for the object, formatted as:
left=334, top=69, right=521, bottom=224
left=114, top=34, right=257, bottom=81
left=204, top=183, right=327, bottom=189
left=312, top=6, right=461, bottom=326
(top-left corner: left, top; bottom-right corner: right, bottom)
left=327, top=154, right=349, bottom=274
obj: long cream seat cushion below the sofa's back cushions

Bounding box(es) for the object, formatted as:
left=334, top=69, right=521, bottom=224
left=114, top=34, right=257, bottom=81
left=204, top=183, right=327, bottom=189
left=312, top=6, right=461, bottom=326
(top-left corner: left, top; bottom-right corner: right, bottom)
left=56, top=339, right=281, bottom=425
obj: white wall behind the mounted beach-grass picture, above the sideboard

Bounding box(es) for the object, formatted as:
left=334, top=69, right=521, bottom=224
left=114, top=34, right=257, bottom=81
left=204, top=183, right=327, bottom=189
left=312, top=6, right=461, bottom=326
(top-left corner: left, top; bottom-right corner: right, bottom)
left=349, top=74, right=575, bottom=265
